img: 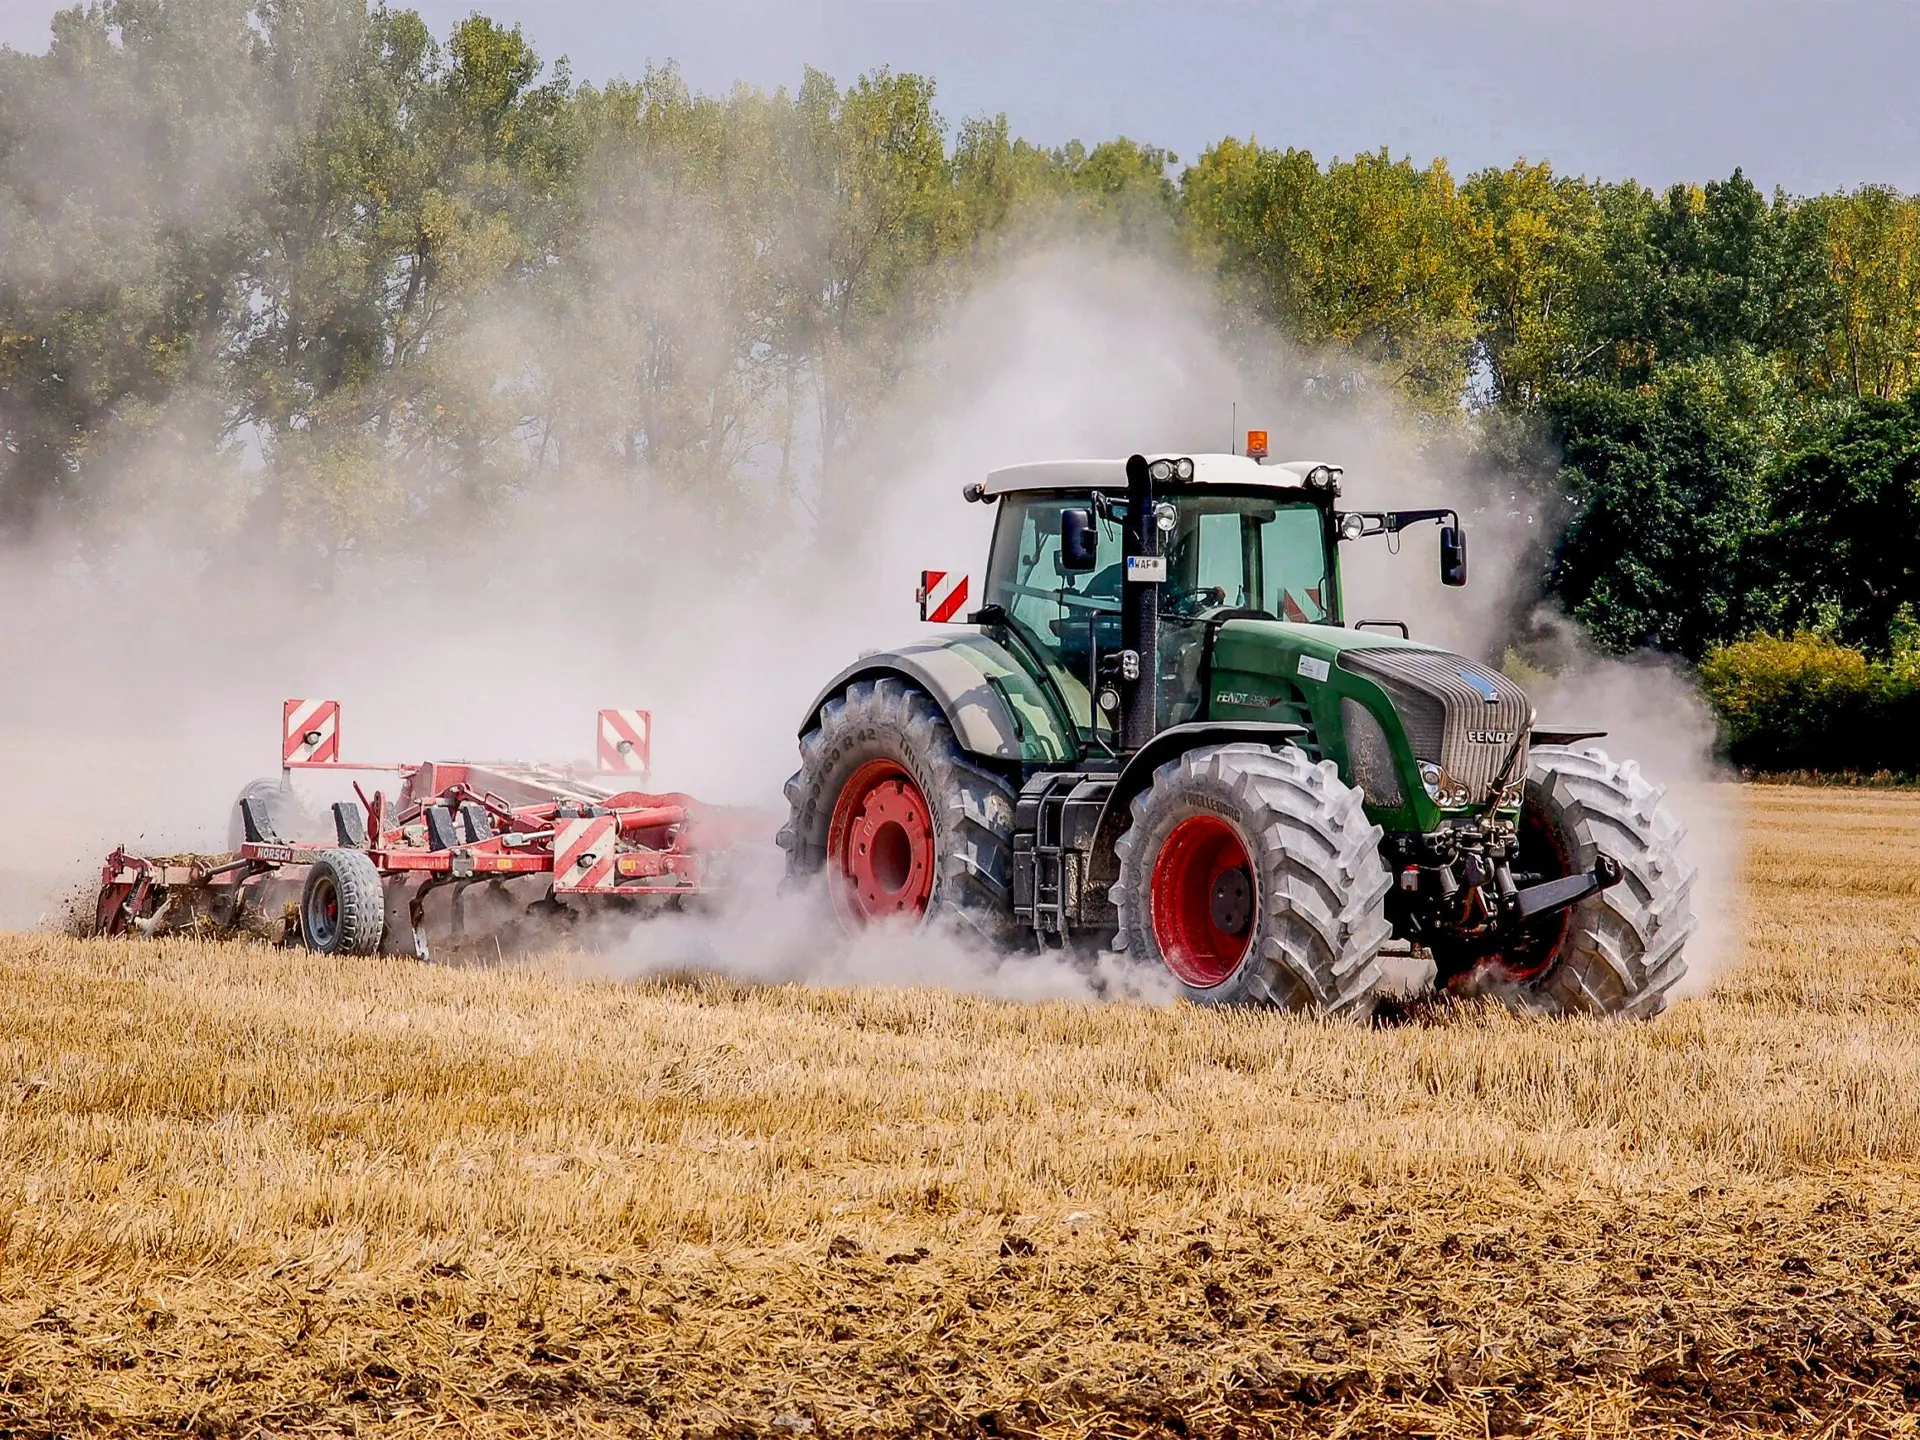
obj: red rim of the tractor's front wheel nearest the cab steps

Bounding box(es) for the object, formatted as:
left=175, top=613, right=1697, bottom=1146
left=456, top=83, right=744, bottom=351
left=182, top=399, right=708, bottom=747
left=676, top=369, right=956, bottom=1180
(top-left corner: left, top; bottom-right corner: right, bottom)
left=1148, top=814, right=1254, bottom=989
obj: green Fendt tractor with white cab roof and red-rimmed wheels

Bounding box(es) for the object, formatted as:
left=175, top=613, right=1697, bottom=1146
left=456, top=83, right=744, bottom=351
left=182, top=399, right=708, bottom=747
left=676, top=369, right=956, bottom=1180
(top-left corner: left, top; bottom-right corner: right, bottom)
left=780, top=445, right=1693, bottom=1016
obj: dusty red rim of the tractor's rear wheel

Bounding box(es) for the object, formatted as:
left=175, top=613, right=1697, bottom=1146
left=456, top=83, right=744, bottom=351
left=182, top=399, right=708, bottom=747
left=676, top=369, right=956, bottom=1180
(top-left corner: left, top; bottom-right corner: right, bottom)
left=828, top=760, right=933, bottom=927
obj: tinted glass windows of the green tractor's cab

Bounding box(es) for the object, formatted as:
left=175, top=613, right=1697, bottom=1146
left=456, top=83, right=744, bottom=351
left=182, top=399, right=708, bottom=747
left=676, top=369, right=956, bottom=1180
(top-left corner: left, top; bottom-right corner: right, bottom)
left=987, top=492, right=1336, bottom=728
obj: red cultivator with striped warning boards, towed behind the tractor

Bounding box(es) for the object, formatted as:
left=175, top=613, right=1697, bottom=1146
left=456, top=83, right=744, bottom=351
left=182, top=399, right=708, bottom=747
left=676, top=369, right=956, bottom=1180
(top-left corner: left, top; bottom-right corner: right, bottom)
left=94, top=701, right=778, bottom=958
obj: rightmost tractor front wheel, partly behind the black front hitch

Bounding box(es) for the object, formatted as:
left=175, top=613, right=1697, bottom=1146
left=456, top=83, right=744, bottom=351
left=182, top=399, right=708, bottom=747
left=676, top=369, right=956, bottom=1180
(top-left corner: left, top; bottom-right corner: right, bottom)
left=1469, top=745, right=1697, bottom=1020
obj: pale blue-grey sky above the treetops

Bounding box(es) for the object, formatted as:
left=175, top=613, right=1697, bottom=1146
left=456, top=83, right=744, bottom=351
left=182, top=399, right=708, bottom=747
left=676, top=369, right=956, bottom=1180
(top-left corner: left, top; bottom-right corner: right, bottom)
left=0, top=0, right=1920, bottom=194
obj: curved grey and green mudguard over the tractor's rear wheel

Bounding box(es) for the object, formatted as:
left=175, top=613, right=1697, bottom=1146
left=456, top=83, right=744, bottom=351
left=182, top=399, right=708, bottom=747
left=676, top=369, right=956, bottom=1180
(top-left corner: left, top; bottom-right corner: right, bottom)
left=801, top=634, right=1079, bottom=764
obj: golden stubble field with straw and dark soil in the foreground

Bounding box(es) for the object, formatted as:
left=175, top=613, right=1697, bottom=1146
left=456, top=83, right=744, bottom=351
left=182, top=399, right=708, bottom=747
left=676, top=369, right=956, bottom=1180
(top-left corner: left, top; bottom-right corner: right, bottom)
left=0, top=787, right=1920, bottom=1436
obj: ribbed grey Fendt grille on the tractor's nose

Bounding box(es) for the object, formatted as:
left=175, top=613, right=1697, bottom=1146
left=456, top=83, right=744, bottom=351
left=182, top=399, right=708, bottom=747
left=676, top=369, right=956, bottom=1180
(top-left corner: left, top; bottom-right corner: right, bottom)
left=1340, top=647, right=1532, bottom=804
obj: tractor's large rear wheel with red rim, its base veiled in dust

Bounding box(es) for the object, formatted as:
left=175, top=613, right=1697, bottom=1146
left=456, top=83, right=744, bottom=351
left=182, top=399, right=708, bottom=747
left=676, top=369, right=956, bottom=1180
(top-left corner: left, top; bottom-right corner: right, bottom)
left=780, top=676, right=1014, bottom=948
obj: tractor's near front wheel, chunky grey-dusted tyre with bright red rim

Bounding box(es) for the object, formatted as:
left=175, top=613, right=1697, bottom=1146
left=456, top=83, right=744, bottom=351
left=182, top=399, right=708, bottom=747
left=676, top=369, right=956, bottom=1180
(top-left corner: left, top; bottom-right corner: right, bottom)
left=1112, top=745, right=1392, bottom=1018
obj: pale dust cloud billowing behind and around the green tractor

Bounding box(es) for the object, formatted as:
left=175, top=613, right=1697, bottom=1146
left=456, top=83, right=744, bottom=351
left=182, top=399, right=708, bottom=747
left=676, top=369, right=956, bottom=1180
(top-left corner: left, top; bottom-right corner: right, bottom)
left=0, top=242, right=1738, bottom=1000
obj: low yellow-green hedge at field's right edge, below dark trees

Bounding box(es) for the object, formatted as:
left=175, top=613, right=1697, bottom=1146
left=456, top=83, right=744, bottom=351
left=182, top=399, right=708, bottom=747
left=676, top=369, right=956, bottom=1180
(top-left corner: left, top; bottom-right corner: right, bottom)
left=1699, top=634, right=1920, bottom=774
